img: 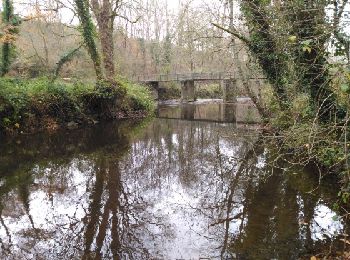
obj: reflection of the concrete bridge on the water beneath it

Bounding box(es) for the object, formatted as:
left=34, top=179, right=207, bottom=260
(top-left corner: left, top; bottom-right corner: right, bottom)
left=158, top=101, right=261, bottom=123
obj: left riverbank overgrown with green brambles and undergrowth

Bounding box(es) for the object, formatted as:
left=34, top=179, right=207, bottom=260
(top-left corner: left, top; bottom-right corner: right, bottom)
left=0, top=78, right=155, bottom=134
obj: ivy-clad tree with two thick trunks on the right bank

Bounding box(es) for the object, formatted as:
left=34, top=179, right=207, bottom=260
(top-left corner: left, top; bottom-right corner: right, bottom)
left=214, top=0, right=344, bottom=121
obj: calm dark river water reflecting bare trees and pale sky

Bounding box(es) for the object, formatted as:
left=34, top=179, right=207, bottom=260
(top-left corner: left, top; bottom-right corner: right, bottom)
left=0, top=103, right=345, bottom=260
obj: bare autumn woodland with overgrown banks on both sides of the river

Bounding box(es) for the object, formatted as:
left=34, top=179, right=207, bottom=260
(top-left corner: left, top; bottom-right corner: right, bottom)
left=0, top=0, right=350, bottom=259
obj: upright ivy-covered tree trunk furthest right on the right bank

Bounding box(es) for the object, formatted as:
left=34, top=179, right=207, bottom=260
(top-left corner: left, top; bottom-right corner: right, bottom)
left=287, top=0, right=337, bottom=122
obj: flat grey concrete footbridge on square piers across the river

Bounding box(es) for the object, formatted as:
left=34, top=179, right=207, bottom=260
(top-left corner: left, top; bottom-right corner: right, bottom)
left=134, top=72, right=262, bottom=103
